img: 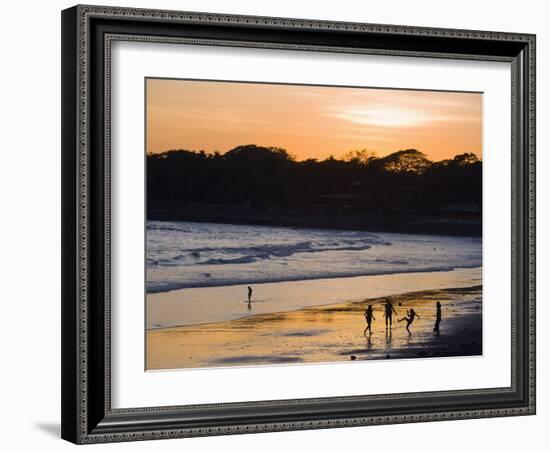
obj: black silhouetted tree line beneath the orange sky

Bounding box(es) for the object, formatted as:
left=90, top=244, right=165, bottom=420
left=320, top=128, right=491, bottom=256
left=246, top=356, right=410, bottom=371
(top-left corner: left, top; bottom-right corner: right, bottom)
left=147, top=145, right=482, bottom=236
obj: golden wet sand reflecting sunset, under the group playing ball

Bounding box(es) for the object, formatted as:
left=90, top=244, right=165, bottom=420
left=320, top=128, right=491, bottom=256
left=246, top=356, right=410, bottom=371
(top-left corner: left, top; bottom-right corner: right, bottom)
left=146, top=285, right=482, bottom=370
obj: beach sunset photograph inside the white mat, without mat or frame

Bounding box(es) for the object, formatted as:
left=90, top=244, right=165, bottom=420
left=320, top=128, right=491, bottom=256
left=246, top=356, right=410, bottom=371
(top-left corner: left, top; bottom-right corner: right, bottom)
left=144, top=77, right=484, bottom=371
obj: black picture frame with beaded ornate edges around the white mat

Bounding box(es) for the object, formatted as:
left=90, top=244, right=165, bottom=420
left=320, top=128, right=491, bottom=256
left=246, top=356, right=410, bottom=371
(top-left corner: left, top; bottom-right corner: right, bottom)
left=62, top=6, right=535, bottom=443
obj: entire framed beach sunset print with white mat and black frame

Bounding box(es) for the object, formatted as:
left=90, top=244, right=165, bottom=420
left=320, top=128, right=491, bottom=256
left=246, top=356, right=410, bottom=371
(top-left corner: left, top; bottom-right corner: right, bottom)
left=62, top=6, right=535, bottom=443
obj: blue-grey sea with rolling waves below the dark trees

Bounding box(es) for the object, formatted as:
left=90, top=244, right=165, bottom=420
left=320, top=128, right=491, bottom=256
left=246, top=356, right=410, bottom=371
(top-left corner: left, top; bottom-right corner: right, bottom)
left=147, top=221, right=482, bottom=293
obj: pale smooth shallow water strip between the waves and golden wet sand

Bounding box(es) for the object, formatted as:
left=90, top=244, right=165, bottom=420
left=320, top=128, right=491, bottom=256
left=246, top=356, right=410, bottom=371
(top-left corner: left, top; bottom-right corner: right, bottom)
left=146, top=267, right=482, bottom=330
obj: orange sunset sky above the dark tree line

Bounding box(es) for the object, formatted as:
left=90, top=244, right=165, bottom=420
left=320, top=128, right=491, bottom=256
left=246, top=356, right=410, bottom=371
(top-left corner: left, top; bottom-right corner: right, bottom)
left=146, top=79, right=482, bottom=161
